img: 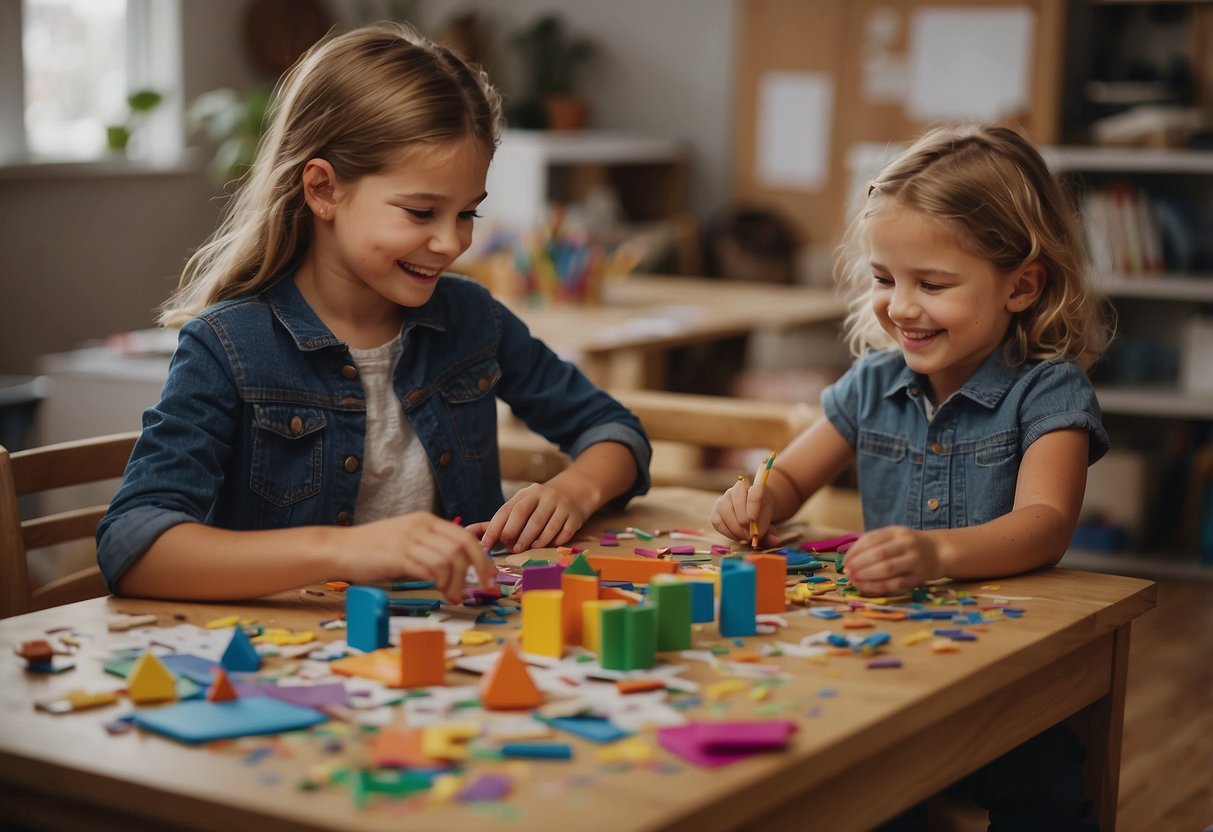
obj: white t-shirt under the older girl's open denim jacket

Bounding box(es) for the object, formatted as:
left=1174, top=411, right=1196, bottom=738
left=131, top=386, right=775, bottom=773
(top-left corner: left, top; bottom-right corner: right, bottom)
left=349, top=338, right=437, bottom=523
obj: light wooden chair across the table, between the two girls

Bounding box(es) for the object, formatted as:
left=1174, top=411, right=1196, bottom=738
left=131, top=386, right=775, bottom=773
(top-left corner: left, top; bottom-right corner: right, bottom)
left=497, top=391, right=862, bottom=529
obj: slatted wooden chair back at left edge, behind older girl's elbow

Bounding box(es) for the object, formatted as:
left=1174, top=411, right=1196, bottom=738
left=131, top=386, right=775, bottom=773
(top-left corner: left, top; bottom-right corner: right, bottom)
left=0, top=432, right=139, bottom=619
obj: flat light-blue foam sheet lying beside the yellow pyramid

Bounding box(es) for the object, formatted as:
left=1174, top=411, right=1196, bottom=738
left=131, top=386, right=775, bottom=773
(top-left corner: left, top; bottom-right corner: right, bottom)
left=135, top=696, right=329, bottom=742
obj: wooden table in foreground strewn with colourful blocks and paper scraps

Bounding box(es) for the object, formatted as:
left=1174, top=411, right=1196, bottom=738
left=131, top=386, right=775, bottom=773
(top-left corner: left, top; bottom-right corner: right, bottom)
left=0, top=489, right=1155, bottom=832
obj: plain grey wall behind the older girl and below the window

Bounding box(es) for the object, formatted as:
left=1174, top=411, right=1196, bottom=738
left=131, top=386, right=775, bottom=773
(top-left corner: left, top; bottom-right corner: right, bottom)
left=0, top=0, right=734, bottom=374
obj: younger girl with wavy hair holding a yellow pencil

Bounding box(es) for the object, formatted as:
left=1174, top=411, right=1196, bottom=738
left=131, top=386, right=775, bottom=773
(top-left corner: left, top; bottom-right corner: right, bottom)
left=712, top=120, right=1109, bottom=830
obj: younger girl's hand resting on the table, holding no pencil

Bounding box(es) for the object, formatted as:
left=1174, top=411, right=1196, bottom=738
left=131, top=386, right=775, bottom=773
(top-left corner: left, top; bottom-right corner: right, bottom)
left=843, top=526, right=941, bottom=595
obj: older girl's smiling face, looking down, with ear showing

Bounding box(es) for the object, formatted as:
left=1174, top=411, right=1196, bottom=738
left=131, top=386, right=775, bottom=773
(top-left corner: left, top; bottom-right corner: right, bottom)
left=301, top=137, right=490, bottom=315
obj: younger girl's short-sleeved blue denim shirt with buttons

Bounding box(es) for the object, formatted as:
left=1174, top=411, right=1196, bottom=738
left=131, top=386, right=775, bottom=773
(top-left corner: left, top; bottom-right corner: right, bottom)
left=821, top=349, right=1109, bottom=529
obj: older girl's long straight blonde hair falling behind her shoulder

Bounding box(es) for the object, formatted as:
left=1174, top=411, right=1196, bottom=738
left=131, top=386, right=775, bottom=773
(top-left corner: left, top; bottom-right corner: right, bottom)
left=160, top=23, right=502, bottom=326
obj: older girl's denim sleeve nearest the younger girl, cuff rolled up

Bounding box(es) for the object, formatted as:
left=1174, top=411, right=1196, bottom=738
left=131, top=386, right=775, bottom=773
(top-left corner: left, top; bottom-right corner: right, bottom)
left=494, top=301, right=653, bottom=505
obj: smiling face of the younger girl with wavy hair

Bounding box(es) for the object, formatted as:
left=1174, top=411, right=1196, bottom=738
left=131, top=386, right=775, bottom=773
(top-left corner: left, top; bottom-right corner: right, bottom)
left=869, top=201, right=1031, bottom=404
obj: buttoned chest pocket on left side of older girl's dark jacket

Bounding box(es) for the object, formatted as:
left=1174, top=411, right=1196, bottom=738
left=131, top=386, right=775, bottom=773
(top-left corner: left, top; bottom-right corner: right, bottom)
left=249, top=404, right=328, bottom=506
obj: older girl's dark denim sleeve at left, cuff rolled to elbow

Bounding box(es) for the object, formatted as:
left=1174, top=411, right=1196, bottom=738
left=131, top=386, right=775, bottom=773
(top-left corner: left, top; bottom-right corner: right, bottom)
left=97, top=320, right=238, bottom=592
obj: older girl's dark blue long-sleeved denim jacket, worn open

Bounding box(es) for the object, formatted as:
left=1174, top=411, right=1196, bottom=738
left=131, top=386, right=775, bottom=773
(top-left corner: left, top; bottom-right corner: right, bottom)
left=97, top=275, right=651, bottom=591
